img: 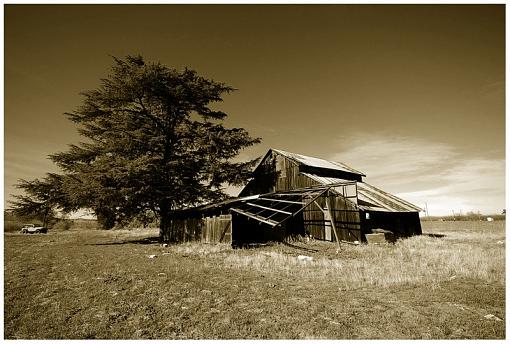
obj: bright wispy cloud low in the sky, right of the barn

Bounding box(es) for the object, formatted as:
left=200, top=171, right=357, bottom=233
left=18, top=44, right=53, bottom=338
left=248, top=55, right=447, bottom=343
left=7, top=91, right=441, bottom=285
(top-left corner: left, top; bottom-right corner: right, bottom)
left=330, top=135, right=505, bottom=215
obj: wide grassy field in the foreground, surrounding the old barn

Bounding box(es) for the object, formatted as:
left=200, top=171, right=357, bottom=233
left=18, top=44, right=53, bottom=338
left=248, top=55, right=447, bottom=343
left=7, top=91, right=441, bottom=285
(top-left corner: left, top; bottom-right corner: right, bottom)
left=4, top=221, right=505, bottom=339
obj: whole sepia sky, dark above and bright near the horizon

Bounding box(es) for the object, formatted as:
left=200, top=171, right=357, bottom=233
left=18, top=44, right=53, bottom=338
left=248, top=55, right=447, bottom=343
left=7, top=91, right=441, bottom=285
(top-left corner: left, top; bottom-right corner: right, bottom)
left=4, top=5, right=505, bottom=215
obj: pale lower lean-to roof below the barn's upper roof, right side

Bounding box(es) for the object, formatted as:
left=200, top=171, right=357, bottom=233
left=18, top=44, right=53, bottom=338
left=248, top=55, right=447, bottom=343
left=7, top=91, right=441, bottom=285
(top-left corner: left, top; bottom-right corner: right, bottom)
left=303, top=173, right=422, bottom=212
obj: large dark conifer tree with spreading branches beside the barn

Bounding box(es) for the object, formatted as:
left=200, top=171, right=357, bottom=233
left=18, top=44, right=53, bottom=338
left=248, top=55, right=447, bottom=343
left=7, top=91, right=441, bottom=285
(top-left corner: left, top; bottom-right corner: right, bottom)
left=51, top=56, right=260, bottom=240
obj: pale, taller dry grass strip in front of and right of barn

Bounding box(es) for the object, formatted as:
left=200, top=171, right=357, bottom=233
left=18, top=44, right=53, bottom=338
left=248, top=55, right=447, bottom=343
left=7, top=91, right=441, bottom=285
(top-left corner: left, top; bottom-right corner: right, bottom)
left=166, top=222, right=505, bottom=290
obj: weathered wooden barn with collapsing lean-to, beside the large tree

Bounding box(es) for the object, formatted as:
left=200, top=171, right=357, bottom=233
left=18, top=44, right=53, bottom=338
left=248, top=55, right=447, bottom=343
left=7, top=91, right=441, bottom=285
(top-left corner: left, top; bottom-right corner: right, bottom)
left=174, top=149, right=421, bottom=246
